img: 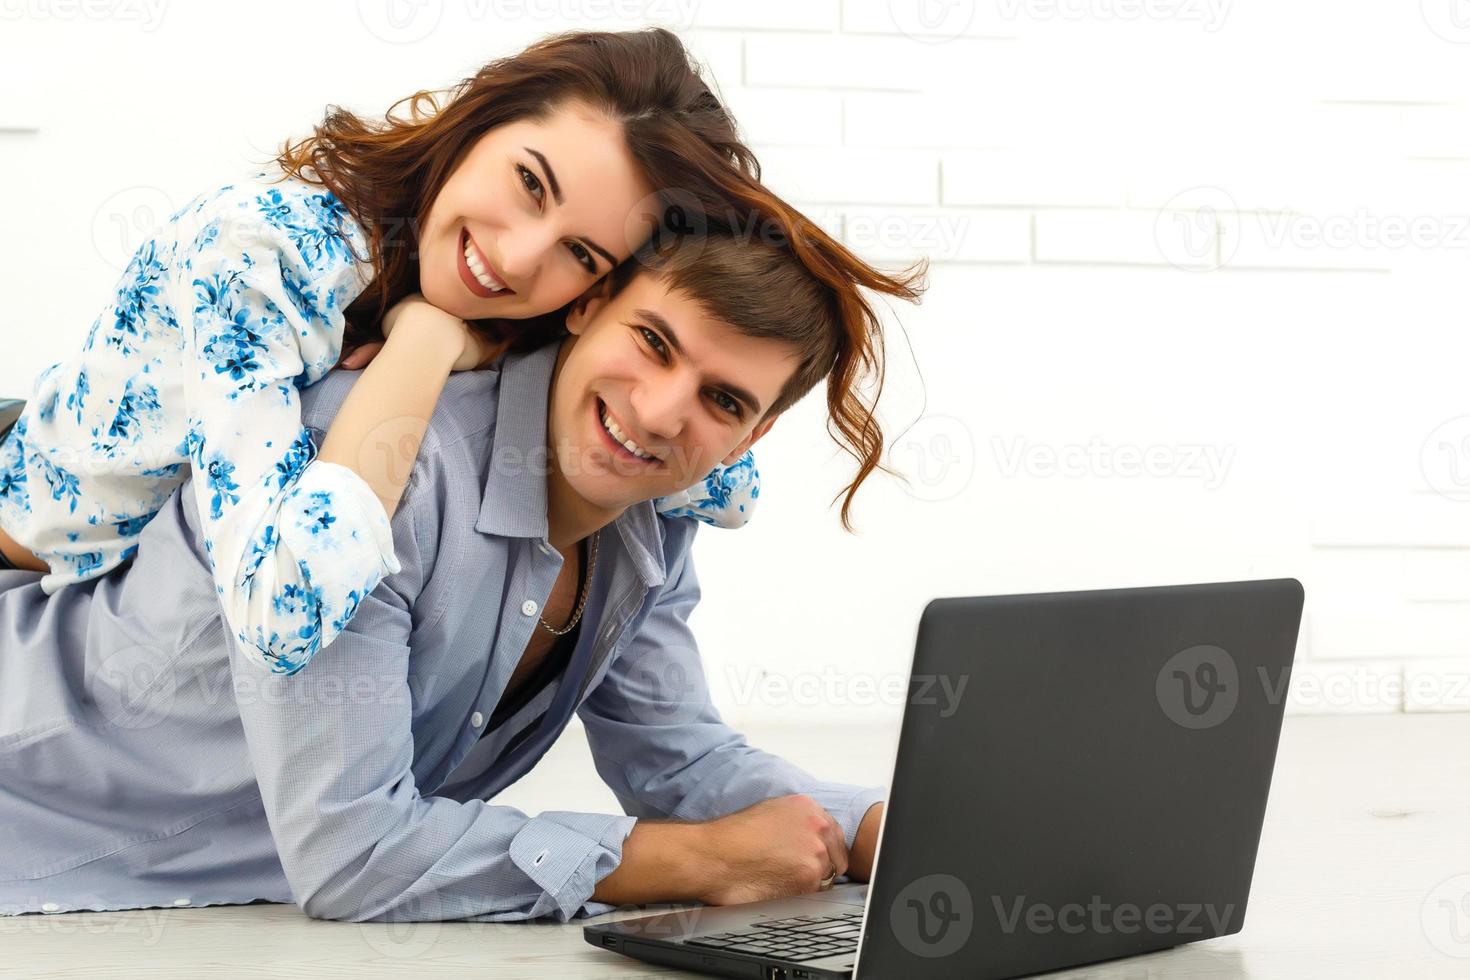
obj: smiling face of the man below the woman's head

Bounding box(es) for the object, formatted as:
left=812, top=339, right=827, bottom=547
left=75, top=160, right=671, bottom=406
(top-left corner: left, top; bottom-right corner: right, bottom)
left=547, top=273, right=798, bottom=513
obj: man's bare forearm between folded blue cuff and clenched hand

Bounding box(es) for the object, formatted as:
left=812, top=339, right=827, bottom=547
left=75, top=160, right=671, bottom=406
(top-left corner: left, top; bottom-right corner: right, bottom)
left=592, top=820, right=711, bottom=905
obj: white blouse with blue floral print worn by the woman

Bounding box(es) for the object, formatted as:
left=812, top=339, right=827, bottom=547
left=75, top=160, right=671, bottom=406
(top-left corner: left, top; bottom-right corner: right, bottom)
left=0, top=172, right=759, bottom=674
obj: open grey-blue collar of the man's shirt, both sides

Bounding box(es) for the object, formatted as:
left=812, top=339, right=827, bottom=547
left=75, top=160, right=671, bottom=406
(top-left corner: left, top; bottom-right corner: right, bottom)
left=475, top=344, right=667, bottom=588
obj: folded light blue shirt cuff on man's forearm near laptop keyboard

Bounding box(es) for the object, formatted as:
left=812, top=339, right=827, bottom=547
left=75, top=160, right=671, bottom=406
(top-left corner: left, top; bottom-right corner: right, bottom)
left=510, top=810, right=638, bottom=923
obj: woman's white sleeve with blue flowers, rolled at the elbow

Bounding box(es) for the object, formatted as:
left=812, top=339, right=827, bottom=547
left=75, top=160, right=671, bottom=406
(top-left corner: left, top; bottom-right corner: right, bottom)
left=176, top=213, right=398, bottom=674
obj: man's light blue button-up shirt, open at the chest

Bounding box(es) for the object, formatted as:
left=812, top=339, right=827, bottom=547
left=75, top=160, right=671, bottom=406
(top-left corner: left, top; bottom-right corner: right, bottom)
left=0, top=347, right=883, bottom=921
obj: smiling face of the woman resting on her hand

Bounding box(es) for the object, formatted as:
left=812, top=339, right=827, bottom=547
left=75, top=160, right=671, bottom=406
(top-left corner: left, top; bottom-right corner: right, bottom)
left=419, top=101, right=657, bottom=320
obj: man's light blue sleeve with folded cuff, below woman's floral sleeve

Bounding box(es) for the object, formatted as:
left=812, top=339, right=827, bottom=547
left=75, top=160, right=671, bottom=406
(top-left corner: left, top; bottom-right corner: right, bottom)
left=231, top=473, right=635, bottom=921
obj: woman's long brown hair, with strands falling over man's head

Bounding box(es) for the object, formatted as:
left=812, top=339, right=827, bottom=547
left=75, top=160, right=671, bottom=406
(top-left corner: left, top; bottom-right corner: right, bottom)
left=276, top=28, right=922, bottom=527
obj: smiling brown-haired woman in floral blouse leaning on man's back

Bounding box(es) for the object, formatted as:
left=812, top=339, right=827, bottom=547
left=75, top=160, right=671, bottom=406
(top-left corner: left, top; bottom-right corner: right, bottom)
left=0, top=29, right=782, bottom=674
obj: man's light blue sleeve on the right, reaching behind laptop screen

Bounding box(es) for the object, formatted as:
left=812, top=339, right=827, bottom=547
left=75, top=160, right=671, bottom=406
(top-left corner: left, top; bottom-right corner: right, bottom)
left=578, top=525, right=886, bottom=848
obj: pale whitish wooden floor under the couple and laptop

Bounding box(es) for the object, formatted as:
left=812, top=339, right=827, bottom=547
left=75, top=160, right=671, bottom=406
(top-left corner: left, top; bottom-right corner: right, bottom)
left=0, top=714, right=1470, bottom=980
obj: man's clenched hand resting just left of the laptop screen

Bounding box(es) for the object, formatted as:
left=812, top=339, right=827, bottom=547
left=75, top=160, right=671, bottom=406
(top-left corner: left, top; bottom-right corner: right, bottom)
left=700, top=795, right=848, bottom=905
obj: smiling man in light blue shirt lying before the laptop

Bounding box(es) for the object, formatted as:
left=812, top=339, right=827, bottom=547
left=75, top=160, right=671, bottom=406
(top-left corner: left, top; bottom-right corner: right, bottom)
left=0, top=238, right=882, bottom=921
